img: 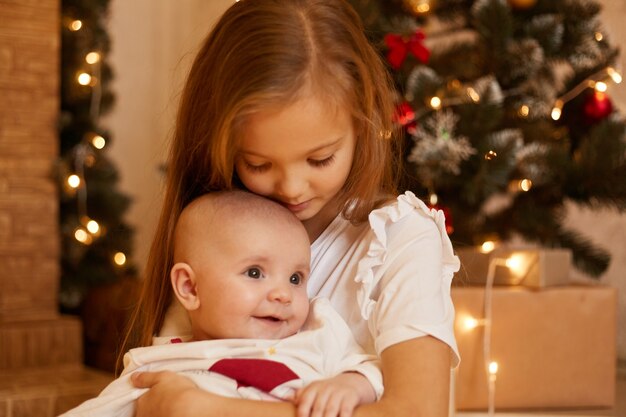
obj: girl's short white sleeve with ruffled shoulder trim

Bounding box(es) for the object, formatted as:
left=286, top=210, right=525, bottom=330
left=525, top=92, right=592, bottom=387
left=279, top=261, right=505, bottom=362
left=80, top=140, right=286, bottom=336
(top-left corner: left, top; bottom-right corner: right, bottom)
left=355, top=192, right=460, bottom=366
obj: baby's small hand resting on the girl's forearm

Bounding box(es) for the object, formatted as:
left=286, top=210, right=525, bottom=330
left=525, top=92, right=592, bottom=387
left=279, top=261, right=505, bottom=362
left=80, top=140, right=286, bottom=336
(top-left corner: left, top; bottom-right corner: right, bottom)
left=294, top=372, right=376, bottom=417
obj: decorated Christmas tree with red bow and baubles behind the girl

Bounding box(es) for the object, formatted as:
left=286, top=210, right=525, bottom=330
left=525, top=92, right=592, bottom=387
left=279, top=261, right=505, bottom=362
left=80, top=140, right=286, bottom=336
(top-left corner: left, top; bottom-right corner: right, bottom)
left=352, top=0, right=626, bottom=277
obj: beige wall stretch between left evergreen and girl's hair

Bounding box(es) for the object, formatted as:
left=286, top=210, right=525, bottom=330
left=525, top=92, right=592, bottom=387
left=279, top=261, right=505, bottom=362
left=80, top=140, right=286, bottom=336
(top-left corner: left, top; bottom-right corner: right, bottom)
left=104, top=0, right=234, bottom=266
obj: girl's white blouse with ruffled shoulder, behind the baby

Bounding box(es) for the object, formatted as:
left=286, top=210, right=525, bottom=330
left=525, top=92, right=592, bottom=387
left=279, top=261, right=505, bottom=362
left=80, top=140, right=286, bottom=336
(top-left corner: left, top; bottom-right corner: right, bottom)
left=308, top=192, right=460, bottom=366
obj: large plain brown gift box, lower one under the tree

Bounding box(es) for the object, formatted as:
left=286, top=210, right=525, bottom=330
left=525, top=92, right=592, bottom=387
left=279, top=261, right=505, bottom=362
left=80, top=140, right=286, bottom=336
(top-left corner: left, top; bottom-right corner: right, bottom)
left=452, top=286, right=617, bottom=410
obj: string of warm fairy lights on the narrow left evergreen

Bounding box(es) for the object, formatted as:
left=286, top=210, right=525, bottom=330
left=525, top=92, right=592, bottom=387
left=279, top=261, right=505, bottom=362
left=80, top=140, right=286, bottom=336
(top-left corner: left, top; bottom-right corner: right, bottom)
left=66, top=14, right=127, bottom=267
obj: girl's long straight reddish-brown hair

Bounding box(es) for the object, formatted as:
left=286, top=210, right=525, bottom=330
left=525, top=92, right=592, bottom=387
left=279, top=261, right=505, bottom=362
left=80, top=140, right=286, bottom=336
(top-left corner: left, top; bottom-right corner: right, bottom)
left=119, top=0, right=399, bottom=358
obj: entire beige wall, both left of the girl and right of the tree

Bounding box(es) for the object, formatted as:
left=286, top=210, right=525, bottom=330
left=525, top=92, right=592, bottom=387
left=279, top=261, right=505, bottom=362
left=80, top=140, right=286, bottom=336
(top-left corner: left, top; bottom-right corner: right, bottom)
left=108, top=0, right=626, bottom=359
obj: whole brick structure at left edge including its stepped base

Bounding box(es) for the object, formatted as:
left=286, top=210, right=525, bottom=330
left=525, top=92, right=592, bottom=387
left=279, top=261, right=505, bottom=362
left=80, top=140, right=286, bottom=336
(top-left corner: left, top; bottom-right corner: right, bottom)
left=0, top=4, right=111, bottom=417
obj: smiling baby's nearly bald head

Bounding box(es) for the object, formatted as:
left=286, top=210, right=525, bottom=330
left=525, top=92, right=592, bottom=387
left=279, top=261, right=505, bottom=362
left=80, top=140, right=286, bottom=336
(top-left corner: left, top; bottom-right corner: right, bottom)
left=171, top=191, right=310, bottom=340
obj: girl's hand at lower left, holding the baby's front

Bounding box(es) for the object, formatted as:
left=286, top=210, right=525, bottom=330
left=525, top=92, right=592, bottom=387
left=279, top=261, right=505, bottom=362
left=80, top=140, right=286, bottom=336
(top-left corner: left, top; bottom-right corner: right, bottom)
left=131, top=371, right=209, bottom=417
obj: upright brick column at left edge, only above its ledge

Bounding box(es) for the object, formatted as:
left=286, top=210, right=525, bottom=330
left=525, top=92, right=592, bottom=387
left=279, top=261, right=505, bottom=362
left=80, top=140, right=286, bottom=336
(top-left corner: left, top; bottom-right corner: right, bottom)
left=0, top=0, right=60, bottom=323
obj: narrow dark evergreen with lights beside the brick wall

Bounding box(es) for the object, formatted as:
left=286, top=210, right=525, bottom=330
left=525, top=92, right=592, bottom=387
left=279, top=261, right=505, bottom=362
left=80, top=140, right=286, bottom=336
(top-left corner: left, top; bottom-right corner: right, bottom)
left=57, top=0, right=134, bottom=311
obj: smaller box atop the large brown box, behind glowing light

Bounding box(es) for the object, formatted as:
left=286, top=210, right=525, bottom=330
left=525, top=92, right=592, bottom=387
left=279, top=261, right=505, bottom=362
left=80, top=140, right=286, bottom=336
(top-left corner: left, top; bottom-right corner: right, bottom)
left=455, top=247, right=572, bottom=288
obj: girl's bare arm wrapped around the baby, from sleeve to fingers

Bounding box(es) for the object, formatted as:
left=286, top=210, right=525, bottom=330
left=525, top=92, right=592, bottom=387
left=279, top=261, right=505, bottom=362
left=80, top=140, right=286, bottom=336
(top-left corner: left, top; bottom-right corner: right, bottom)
left=133, top=336, right=450, bottom=417
